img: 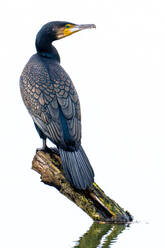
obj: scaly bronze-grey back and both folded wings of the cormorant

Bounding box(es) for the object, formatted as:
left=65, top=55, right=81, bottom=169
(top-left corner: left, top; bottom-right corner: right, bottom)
left=20, top=55, right=81, bottom=146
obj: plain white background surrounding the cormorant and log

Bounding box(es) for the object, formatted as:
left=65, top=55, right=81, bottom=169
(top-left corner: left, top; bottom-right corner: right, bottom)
left=0, top=0, right=165, bottom=248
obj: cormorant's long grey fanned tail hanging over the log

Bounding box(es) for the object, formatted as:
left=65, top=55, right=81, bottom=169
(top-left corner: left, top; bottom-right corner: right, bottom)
left=59, top=145, right=94, bottom=190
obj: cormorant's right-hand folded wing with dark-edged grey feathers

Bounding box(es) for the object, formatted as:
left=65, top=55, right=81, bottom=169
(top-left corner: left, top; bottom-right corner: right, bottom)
left=48, top=60, right=81, bottom=143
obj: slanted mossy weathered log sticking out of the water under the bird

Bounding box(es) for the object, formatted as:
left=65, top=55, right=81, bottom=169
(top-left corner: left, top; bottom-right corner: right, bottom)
left=32, top=149, right=132, bottom=223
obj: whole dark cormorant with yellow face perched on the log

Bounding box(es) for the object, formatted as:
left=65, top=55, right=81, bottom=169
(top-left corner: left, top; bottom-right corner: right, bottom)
left=20, top=21, right=95, bottom=190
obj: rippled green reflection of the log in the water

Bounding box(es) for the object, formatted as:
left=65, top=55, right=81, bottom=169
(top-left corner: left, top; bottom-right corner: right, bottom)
left=74, top=222, right=128, bottom=248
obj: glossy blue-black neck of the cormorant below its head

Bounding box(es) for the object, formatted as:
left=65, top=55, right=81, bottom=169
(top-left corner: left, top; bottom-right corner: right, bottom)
left=36, top=36, right=60, bottom=63
